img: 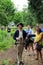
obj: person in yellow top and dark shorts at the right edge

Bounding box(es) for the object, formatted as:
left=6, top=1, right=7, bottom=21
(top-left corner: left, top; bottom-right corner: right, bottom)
left=34, top=27, right=43, bottom=61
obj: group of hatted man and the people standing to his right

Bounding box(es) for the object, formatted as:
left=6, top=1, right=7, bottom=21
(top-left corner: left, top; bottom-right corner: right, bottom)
left=13, top=23, right=43, bottom=65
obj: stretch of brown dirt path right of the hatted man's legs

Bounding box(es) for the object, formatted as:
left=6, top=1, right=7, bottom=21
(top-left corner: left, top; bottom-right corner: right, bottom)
left=23, top=50, right=43, bottom=65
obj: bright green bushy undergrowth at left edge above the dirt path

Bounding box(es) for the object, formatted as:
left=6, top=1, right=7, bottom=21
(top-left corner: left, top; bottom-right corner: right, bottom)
left=0, top=30, right=14, bottom=50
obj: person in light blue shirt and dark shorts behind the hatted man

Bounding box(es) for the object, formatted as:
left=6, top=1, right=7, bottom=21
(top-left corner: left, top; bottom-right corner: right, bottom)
left=26, top=25, right=35, bottom=56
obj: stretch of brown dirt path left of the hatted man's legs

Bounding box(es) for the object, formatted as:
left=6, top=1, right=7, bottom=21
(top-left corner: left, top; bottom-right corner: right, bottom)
left=0, top=46, right=17, bottom=65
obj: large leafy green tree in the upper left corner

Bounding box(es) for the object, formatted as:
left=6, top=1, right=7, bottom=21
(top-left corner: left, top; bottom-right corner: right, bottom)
left=0, top=0, right=16, bottom=26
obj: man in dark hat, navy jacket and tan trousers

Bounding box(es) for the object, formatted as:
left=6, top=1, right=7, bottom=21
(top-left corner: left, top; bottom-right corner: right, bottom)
left=13, top=23, right=27, bottom=65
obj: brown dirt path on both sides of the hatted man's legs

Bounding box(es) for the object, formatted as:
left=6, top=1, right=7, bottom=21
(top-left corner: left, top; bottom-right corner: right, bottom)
left=0, top=46, right=43, bottom=65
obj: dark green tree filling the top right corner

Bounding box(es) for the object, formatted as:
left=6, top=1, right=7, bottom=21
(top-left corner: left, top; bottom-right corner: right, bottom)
left=28, top=0, right=43, bottom=23
